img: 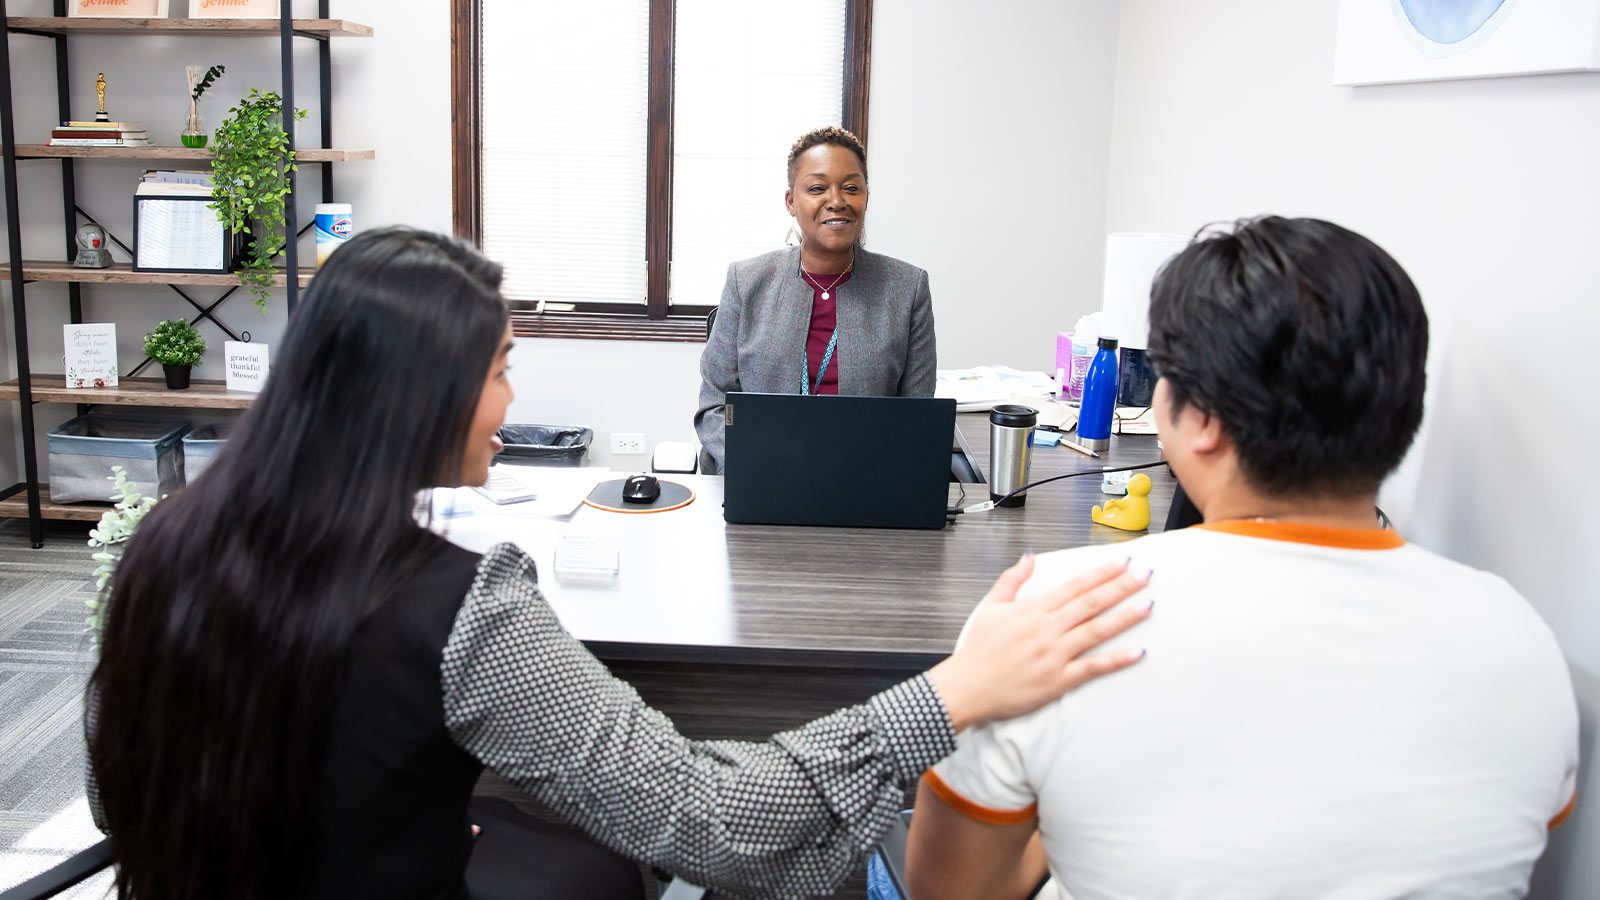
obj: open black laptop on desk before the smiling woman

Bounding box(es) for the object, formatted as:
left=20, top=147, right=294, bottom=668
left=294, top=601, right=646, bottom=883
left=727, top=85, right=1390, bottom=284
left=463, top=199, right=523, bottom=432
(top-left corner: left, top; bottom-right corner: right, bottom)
left=722, top=394, right=955, bottom=528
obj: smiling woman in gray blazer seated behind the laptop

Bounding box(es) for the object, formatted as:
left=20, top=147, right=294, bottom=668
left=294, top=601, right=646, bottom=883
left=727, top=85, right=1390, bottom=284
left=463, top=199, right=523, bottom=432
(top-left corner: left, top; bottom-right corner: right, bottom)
left=694, top=127, right=938, bottom=474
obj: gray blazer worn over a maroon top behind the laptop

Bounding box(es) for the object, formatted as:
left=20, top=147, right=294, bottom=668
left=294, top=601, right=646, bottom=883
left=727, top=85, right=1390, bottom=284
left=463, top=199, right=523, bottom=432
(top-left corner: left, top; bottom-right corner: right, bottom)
left=694, top=247, right=939, bottom=474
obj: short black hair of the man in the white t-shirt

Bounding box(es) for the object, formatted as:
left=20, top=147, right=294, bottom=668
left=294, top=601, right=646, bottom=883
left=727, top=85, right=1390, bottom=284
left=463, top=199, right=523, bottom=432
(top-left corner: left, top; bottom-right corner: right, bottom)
left=1149, top=216, right=1427, bottom=496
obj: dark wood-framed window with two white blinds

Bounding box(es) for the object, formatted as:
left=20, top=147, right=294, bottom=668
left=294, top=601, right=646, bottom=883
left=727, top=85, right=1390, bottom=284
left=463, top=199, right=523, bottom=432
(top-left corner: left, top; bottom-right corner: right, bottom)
left=453, top=0, right=872, bottom=341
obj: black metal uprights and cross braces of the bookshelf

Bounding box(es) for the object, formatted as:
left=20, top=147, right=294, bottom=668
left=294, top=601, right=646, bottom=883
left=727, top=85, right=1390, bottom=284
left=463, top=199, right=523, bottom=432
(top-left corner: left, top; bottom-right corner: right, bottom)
left=0, top=0, right=352, bottom=549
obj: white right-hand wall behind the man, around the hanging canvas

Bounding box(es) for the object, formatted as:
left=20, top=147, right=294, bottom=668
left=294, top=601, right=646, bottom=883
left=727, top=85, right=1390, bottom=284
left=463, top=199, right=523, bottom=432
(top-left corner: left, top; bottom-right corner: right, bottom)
left=1107, top=0, right=1600, bottom=900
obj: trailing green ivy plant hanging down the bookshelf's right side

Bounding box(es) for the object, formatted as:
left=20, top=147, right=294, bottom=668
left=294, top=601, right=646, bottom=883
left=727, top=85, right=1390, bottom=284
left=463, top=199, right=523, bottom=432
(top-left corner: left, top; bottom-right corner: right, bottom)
left=211, top=88, right=306, bottom=312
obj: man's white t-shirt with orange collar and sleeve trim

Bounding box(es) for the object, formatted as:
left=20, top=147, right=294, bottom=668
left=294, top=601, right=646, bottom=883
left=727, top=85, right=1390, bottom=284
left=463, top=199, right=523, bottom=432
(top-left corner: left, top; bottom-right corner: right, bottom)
left=928, top=522, right=1578, bottom=900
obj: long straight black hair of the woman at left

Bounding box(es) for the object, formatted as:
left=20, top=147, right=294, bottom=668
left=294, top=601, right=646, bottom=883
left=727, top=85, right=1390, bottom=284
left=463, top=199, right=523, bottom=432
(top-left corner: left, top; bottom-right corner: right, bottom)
left=90, top=229, right=506, bottom=900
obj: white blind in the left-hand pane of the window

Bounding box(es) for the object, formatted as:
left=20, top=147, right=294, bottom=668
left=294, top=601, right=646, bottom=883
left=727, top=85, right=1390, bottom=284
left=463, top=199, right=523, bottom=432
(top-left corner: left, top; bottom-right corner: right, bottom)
left=478, top=0, right=650, bottom=306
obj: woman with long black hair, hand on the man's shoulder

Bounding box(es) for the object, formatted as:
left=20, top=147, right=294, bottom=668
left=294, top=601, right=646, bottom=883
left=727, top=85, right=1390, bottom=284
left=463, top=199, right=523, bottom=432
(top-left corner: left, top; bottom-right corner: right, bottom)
left=86, top=229, right=1147, bottom=900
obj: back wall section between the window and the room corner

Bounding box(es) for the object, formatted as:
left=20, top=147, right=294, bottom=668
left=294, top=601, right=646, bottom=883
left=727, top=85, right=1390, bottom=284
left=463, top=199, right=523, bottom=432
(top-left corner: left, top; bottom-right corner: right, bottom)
left=866, top=0, right=1117, bottom=370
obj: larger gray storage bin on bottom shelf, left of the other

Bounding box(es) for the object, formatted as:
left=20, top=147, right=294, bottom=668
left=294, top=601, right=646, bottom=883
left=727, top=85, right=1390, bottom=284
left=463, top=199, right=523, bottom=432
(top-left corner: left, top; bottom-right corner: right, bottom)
left=50, top=413, right=189, bottom=503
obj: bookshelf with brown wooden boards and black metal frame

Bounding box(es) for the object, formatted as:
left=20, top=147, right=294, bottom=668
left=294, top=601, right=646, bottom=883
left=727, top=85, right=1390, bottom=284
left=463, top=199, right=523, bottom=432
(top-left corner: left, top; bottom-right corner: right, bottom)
left=0, top=0, right=376, bottom=548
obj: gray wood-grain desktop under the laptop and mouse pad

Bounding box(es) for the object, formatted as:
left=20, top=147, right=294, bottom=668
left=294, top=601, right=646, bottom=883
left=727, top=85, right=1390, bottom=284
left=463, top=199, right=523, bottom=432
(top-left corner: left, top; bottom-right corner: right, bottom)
left=448, top=413, right=1174, bottom=671
